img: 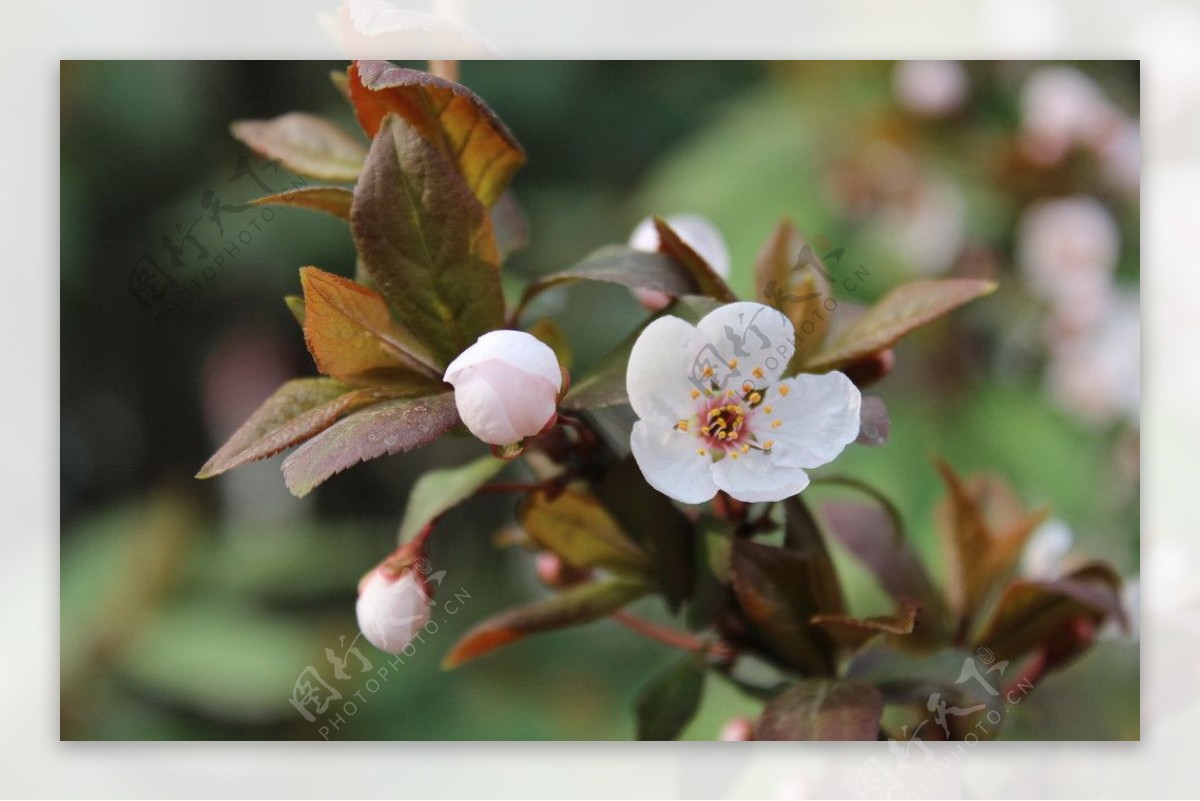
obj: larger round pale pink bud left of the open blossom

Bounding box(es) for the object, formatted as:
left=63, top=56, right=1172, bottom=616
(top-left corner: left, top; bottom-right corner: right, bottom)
left=444, top=331, right=563, bottom=445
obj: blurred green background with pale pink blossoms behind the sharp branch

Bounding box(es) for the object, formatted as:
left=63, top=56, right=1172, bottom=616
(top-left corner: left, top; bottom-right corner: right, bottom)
left=61, top=61, right=1139, bottom=740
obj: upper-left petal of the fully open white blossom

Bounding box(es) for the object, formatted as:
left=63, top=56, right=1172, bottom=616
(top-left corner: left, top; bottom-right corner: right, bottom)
left=625, top=315, right=704, bottom=424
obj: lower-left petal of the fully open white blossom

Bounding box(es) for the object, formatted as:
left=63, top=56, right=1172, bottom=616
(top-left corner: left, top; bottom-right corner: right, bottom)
left=629, top=417, right=716, bottom=504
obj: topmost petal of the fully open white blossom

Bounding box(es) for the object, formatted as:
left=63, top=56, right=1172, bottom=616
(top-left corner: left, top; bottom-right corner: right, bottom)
left=697, top=301, right=796, bottom=384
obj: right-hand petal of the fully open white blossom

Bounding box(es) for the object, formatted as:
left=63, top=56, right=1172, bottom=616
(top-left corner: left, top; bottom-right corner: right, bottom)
left=760, top=373, right=863, bottom=468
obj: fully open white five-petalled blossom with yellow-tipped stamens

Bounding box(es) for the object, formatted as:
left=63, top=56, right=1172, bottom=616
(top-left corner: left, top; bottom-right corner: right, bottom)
left=625, top=302, right=862, bottom=504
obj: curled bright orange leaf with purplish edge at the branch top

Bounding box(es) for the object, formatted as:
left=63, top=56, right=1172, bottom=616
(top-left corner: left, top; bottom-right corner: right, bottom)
left=349, top=61, right=526, bottom=206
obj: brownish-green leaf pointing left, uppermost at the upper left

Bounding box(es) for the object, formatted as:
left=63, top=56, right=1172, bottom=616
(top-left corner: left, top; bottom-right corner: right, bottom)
left=229, top=112, right=367, bottom=181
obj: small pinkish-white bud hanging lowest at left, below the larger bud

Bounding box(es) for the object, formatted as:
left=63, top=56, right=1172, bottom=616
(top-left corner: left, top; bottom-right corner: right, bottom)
left=355, top=565, right=432, bottom=654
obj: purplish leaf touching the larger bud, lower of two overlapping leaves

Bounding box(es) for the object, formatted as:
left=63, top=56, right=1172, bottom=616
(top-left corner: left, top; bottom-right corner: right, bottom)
left=283, top=392, right=460, bottom=498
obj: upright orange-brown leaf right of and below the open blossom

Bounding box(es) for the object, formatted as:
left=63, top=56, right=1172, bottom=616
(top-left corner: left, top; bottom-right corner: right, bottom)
left=934, top=462, right=1048, bottom=625
